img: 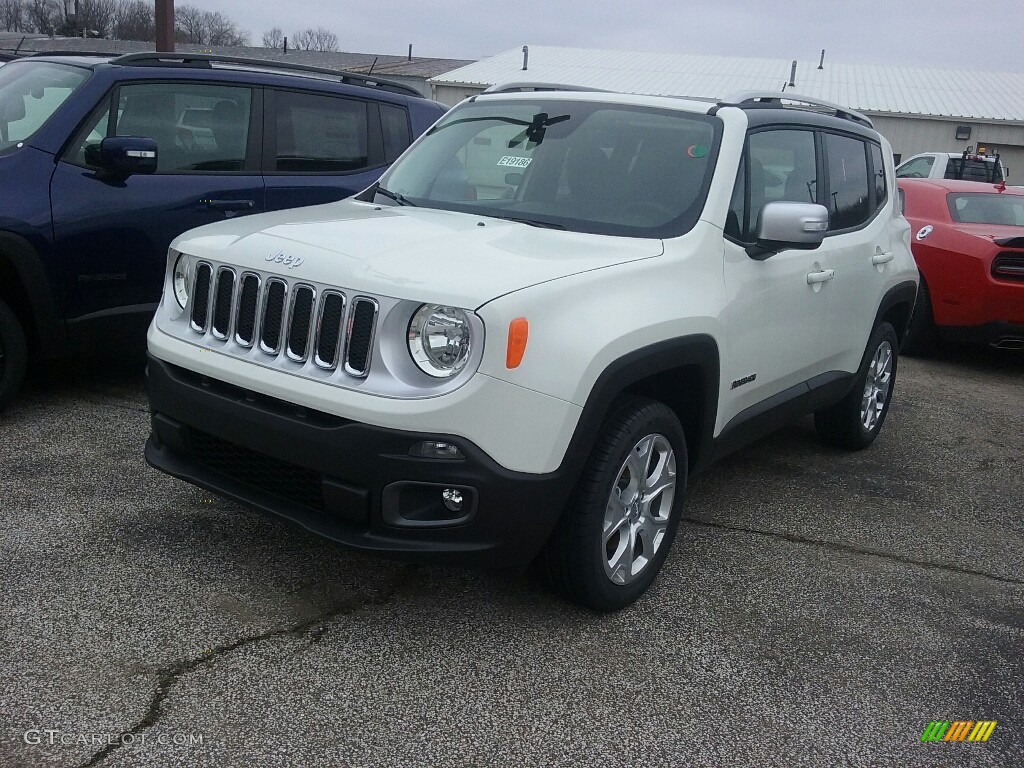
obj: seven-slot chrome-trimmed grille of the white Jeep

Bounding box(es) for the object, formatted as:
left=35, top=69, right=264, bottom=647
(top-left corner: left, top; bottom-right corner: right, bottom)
left=186, top=261, right=379, bottom=378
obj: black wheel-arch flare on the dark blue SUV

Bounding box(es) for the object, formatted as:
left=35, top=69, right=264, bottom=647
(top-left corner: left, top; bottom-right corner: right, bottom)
left=0, top=231, right=67, bottom=357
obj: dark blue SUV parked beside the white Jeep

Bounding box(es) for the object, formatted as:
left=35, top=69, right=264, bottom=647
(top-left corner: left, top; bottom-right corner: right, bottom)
left=0, top=53, right=445, bottom=409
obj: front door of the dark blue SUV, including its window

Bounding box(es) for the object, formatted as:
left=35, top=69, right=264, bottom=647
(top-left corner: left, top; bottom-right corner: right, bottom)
left=50, top=81, right=264, bottom=322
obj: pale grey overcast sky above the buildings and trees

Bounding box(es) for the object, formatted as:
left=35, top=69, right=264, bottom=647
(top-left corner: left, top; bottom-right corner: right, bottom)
left=207, top=0, right=1024, bottom=72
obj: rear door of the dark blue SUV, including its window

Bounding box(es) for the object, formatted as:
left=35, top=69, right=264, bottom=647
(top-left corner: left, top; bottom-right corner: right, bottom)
left=263, top=88, right=412, bottom=210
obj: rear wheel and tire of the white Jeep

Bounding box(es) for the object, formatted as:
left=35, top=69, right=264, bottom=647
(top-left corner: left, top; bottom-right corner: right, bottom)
left=814, top=323, right=899, bottom=451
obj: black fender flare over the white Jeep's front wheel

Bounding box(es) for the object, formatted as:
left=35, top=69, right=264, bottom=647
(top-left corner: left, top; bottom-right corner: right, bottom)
left=561, top=334, right=721, bottom=478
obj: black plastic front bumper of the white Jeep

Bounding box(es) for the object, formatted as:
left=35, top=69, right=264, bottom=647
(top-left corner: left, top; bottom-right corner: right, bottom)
left=145, top=356, right=572, bottom=567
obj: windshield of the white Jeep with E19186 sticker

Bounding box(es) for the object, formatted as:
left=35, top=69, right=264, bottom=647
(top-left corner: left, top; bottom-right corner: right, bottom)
left=376, top=98, right=721, bottom=238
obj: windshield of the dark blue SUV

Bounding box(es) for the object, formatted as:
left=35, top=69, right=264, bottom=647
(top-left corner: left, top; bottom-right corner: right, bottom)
left=0, top=61, right=89, bottom=152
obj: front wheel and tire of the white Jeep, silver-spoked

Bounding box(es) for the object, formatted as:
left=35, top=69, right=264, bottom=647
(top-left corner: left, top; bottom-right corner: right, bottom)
left=543, top=397, right=687, bottom=611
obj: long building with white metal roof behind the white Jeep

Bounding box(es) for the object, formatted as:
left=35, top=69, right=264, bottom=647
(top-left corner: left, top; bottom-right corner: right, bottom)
left=430, top=46, right=1024, bottom=174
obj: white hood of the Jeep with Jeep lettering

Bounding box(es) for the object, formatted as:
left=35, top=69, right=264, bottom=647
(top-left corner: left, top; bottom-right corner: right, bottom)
left=172, top=200, right=663, bottom=309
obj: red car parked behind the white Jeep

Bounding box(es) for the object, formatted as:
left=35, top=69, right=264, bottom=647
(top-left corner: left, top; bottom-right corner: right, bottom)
left=899, top=178, right=1024, bottom=354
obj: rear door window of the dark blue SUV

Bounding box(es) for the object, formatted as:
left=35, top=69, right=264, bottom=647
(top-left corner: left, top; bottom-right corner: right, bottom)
left=273, top=91, right=369, bottom=173
